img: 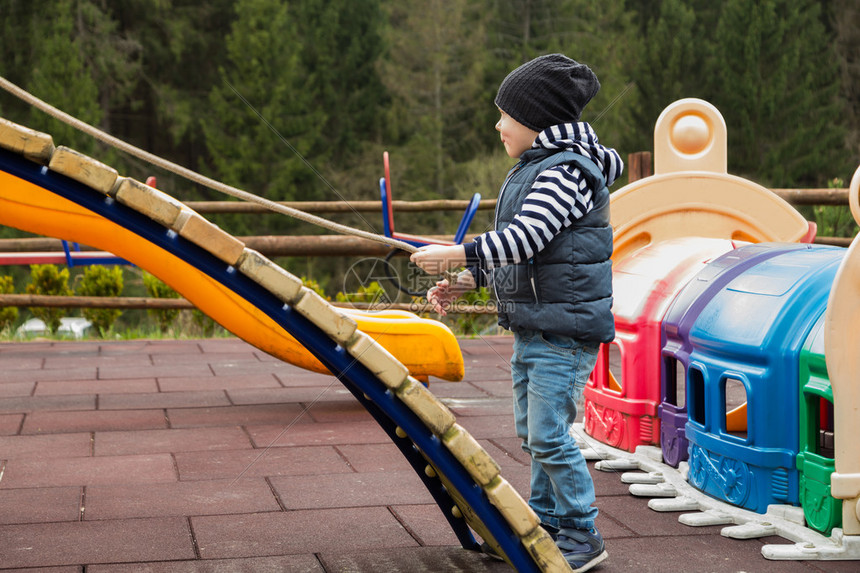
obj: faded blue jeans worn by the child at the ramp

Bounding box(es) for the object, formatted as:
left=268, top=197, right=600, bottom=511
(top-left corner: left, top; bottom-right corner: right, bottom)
left=511, top=330, right=598, bottom=529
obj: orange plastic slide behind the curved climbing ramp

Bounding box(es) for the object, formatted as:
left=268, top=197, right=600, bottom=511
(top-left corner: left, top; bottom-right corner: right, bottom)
left=0, top=161, right=464, bottom=380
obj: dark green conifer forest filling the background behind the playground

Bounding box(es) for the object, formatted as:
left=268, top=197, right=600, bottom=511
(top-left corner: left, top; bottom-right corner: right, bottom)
left=0, top=0, right=860, bottom=298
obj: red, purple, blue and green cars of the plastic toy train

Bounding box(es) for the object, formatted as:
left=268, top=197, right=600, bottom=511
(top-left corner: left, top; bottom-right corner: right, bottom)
left=585, top=239, right=845, bottom=533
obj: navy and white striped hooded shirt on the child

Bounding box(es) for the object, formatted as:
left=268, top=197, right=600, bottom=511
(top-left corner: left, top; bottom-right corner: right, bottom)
left=466, top=122, right=624, bottom=270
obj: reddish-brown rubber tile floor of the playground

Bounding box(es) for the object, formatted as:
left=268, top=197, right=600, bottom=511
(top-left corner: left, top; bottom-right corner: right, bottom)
left=0, top=337, right=860, bottom=573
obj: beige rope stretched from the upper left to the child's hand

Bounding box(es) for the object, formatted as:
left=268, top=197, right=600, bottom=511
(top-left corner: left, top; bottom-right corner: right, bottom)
left=0, top=76, right=418, bottom=253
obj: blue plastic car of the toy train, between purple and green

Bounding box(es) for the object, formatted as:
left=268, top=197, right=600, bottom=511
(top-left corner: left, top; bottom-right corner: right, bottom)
left=685, top=245, right=845, bottom=513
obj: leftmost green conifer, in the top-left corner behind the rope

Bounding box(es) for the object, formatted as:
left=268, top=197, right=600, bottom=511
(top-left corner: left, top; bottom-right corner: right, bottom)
left=0, top=0, right=140, bottom=163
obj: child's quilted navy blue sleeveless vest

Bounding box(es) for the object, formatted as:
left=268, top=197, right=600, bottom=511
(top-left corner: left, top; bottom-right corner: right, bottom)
left=492, top=149, right=615, bottom=343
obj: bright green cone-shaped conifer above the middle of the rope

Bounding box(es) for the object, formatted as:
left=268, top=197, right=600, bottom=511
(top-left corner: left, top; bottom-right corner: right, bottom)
left=203, top=0, right=326, bottom=234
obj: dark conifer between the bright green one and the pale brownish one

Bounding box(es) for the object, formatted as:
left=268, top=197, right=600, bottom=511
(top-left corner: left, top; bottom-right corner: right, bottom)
left=280, top=0, right=390, bottom=219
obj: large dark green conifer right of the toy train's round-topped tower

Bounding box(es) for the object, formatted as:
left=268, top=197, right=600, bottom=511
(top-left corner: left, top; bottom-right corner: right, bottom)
left=708, top=0, right=847, bottom=187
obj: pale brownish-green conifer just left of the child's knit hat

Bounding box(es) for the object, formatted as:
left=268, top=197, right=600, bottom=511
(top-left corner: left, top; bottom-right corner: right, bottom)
left=381, top=0, right=492, bottom=197
